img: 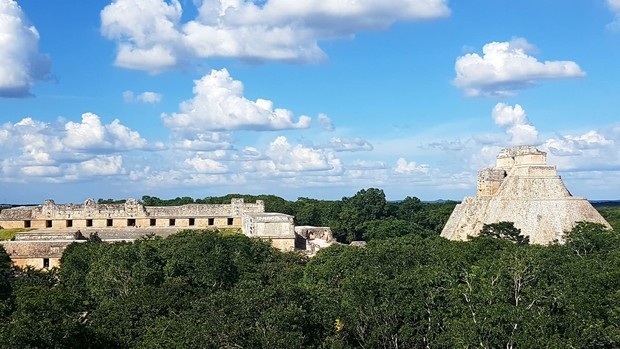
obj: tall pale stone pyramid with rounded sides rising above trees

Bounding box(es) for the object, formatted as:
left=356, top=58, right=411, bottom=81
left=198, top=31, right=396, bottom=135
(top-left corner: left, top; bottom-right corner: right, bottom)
left=441, top=146, right=611, bottom=244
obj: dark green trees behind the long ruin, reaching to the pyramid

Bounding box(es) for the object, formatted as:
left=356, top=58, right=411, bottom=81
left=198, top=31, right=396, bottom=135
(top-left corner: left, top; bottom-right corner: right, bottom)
left=140, top=188, right=456, bottom=242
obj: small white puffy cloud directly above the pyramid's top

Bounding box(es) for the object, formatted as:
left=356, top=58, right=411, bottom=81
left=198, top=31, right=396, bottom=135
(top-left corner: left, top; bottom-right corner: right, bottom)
left=492, top=103, right=538, bottom=145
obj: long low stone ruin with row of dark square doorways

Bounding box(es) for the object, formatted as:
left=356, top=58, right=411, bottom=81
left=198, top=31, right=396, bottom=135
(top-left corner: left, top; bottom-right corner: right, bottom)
left=0, top=199, right=333, bottom=268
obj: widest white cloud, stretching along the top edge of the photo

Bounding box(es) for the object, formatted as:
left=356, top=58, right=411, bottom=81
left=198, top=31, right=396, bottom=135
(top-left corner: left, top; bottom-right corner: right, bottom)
left=101, top=0, right=450, bottom=73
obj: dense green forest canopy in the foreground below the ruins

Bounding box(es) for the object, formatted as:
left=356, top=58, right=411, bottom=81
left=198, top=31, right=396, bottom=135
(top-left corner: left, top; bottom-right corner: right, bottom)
left=0, top=223, right=620, bottom=348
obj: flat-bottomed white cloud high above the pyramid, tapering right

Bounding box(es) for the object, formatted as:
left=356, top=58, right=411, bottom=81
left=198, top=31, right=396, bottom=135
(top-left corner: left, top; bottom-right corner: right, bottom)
left=453, top=39, right=586, bottom=97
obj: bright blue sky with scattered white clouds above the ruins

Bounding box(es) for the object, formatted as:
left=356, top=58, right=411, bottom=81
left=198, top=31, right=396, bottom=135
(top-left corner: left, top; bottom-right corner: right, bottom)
left=0, top=0, right=620, bottom=203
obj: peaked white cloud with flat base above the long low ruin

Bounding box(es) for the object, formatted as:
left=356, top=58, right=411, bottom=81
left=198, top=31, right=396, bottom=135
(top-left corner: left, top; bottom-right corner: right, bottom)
left=162, top=69, right=310, bottom=132
